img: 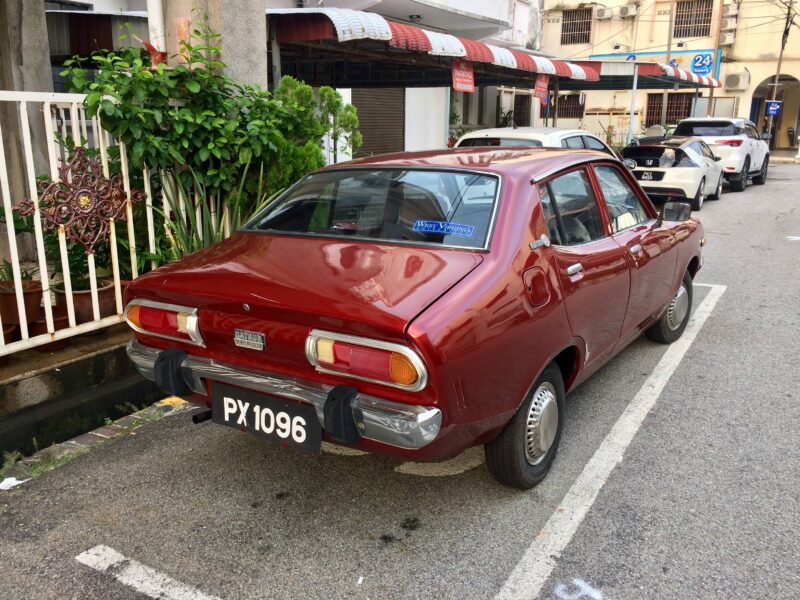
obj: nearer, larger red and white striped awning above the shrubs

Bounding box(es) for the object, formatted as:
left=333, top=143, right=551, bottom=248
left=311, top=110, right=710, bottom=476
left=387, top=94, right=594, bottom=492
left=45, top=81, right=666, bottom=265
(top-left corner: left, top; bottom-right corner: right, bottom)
left=267, top=8, right=599, bottom=81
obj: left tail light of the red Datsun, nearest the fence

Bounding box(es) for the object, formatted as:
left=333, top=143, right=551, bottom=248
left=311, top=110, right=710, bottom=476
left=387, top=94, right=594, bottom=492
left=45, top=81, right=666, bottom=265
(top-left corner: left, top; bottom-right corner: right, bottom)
left=125, top=299, right=204, bottom=346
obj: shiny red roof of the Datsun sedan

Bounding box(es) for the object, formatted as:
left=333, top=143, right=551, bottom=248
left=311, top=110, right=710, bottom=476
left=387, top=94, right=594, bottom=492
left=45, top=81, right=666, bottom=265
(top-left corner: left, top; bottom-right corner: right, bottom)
left=322, top=146, right=611, bottom=180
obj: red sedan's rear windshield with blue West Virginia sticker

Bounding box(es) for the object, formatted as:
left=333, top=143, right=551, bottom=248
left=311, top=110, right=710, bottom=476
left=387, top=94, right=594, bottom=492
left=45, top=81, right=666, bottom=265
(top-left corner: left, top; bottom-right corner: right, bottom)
left=245, top=169, right=499, bottom=248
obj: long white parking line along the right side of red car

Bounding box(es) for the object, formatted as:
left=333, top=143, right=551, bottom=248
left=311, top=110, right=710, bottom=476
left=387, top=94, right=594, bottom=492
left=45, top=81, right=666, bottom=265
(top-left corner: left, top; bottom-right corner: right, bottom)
left=495, top=284, right=726, bottom=600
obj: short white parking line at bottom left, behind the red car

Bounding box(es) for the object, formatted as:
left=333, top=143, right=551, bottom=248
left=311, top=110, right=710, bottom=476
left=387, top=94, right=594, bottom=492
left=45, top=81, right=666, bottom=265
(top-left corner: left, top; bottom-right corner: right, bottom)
left=75, top=546, right=220, bottom=600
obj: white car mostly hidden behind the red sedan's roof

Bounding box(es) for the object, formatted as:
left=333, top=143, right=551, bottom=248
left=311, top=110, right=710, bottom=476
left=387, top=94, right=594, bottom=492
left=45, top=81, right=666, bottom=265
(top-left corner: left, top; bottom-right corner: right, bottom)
left=455, top=127, right=619, bottom=158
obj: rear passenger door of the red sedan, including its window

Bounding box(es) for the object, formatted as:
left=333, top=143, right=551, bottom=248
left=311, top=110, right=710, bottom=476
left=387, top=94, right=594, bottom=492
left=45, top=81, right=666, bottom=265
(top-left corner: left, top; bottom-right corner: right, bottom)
left=539, top=167, right=629, bottom=365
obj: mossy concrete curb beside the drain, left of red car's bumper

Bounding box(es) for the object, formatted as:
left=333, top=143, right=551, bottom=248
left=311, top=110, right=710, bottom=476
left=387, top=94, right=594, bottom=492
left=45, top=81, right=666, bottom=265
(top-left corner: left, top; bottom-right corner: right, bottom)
left=0, top=396, right=194, bottom=490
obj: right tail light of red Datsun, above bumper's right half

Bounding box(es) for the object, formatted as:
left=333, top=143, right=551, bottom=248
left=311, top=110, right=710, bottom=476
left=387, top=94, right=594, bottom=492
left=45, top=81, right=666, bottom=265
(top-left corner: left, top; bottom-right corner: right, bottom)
left=306, top=329, right=428, bottom=392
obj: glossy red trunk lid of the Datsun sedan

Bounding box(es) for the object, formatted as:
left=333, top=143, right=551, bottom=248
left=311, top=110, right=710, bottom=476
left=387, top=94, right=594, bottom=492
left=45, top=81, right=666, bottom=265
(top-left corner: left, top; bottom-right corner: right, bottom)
left=128, top=233, right=483, bottom=368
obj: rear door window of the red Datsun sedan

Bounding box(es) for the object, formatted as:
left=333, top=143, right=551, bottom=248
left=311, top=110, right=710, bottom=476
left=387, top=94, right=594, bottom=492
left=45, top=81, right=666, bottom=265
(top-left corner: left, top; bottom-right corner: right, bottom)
left=547, top=169, right=605, bottom=246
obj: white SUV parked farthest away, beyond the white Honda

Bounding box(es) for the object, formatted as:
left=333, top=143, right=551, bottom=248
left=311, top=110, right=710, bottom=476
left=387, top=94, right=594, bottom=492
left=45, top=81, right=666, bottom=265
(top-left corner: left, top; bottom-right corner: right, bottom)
left=674, top=117, right=769, bottom=192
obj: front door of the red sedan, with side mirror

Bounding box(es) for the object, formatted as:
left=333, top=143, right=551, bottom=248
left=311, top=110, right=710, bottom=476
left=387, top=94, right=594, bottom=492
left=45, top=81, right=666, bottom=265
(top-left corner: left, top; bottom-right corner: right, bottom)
left=594, top=164, right=677, bottom=338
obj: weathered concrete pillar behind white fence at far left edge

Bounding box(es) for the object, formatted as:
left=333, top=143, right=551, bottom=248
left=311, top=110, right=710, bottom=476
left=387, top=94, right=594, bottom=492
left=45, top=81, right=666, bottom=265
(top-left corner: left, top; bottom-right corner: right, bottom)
left=0, top=0, right=53, bottom=256
